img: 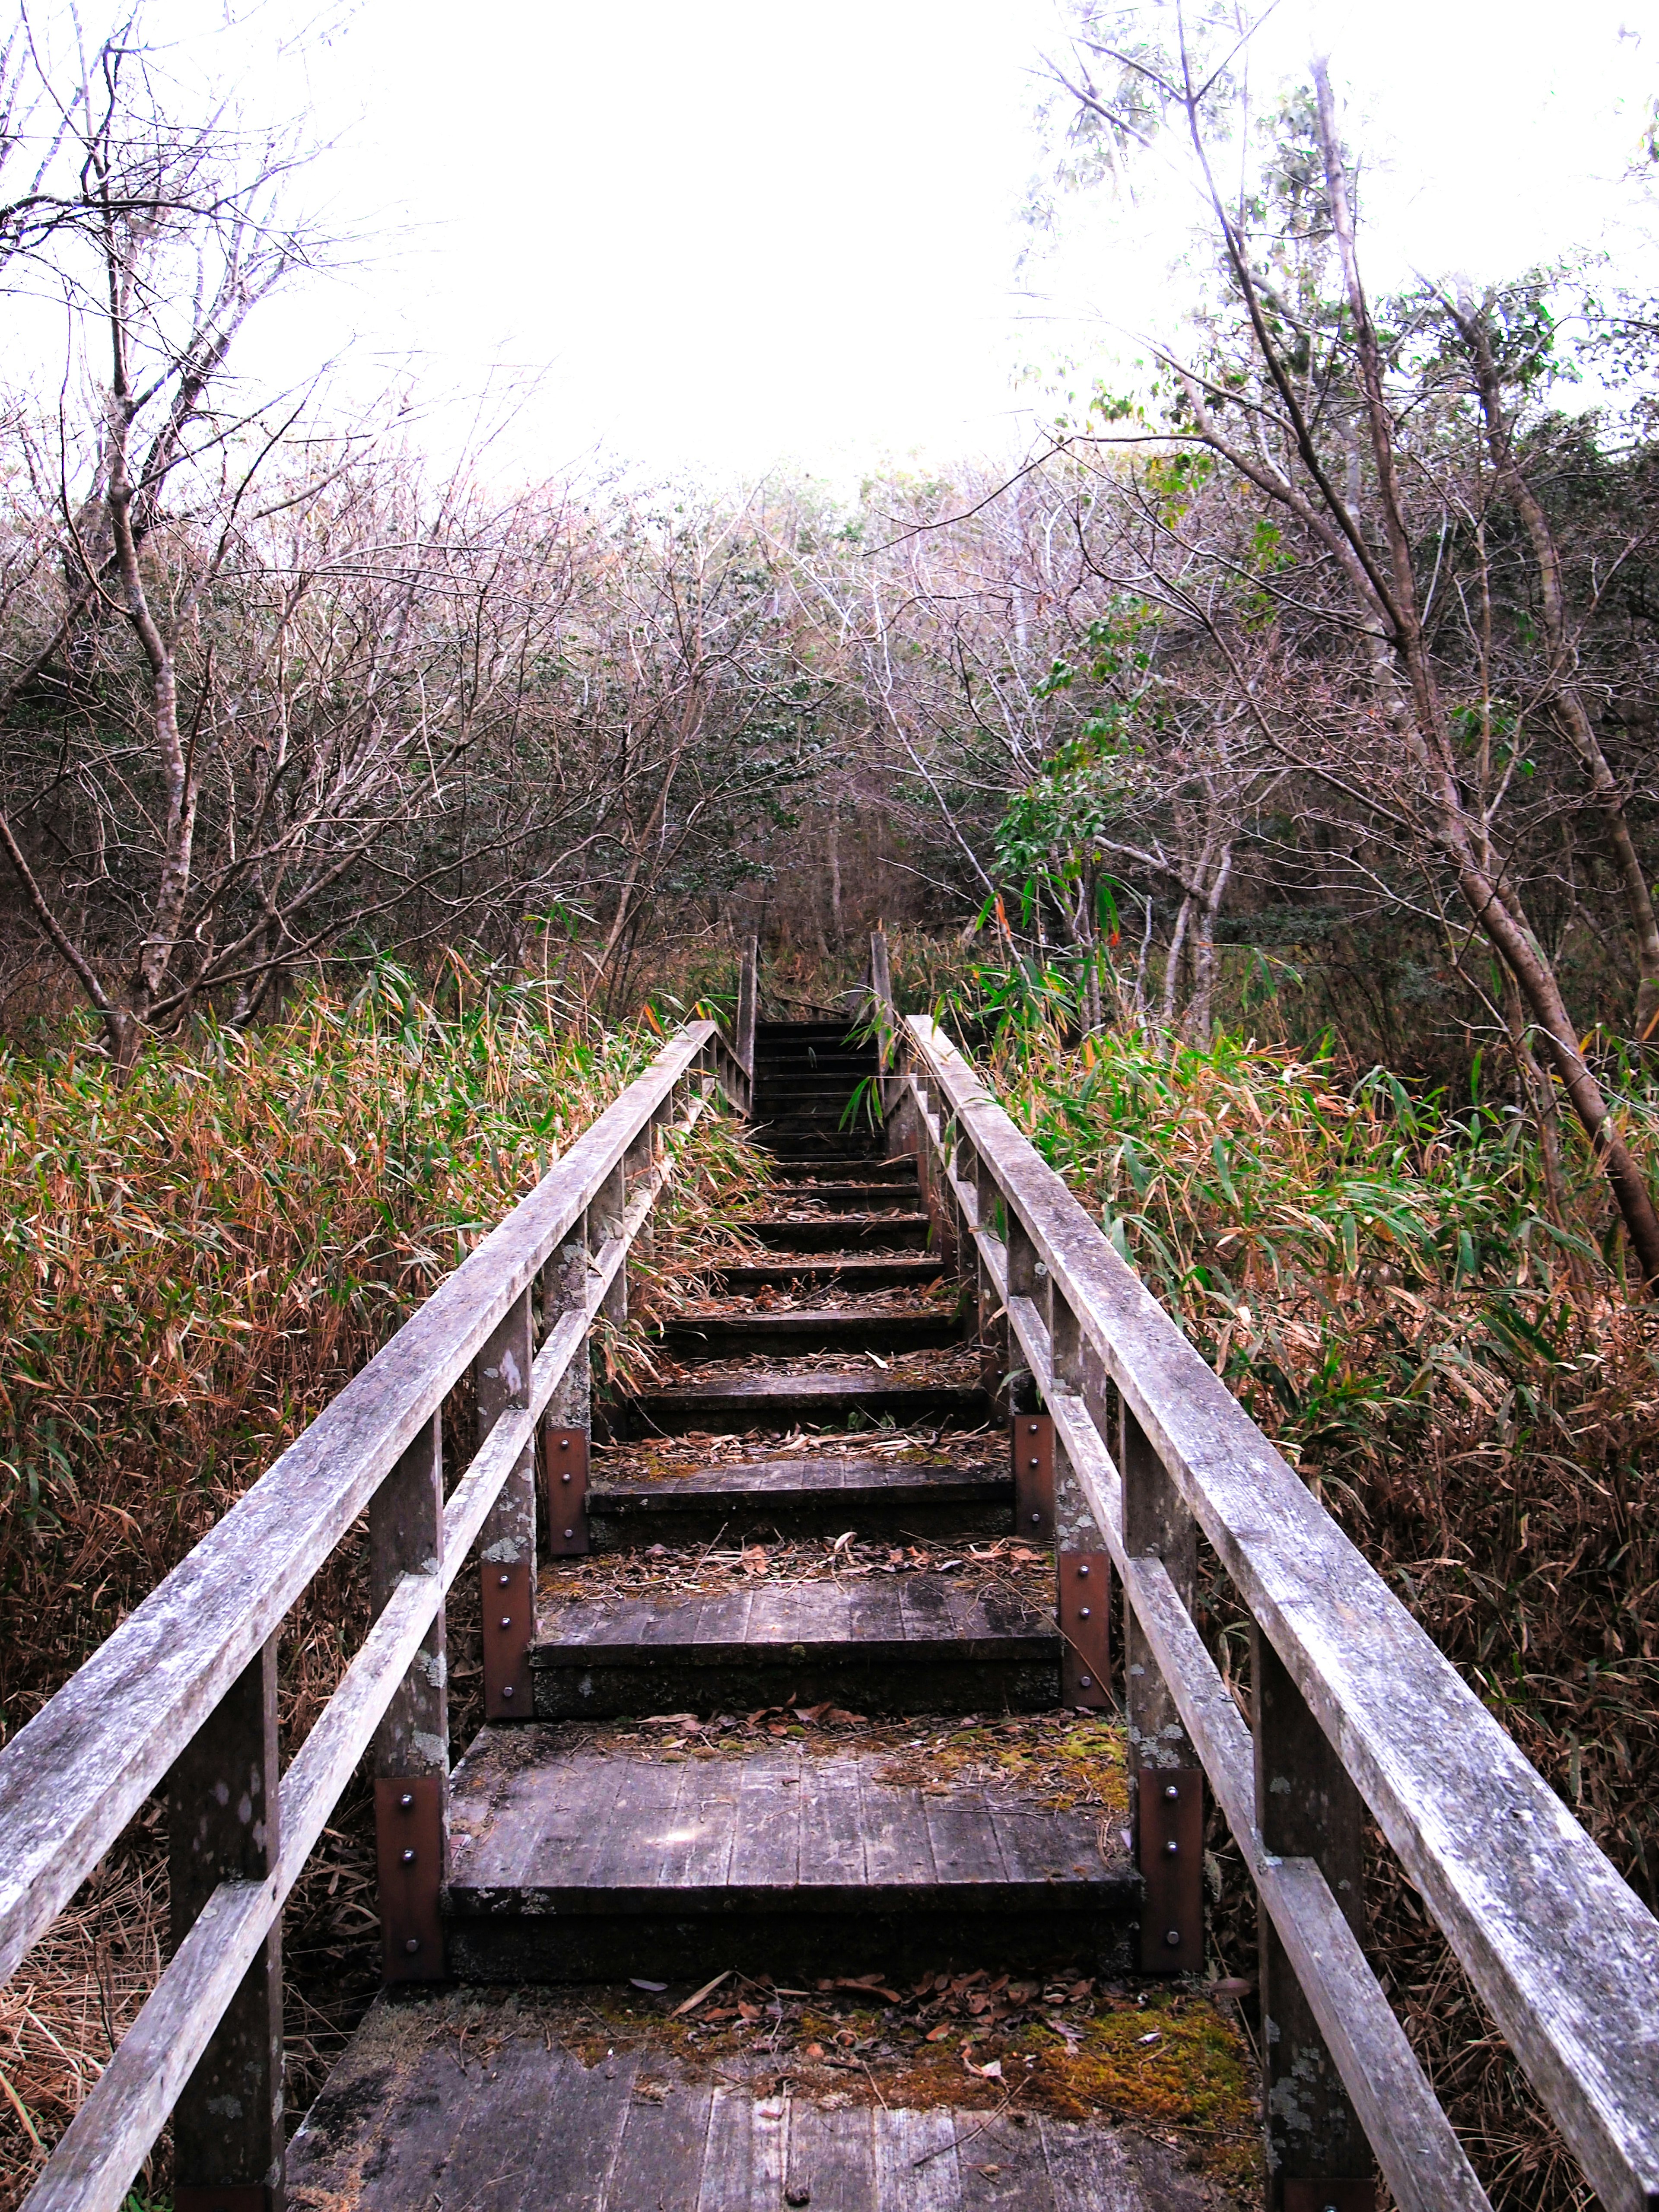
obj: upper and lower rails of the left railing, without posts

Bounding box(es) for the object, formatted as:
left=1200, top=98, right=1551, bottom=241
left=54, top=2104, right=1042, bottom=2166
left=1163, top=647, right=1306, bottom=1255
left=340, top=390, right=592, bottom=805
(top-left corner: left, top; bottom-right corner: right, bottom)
left=0, top=1022, right=745, bottom=2212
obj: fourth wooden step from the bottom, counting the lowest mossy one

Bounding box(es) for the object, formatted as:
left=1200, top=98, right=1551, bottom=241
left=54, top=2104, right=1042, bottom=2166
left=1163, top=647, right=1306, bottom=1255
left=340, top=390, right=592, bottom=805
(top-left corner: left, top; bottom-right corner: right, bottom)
left=588, top=1458, right=1013, bottom=1548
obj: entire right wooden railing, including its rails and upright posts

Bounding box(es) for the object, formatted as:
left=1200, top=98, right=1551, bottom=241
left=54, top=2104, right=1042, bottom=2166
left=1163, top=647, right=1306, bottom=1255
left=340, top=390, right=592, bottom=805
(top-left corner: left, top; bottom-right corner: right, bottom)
left=889, top=986, right=1659, bottom=2212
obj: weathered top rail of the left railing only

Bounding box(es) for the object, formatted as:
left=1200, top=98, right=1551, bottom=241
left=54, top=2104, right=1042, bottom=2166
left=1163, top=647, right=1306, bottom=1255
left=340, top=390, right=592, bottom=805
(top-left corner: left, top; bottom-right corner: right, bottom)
left=0, top=1022, right=712, bottom=1980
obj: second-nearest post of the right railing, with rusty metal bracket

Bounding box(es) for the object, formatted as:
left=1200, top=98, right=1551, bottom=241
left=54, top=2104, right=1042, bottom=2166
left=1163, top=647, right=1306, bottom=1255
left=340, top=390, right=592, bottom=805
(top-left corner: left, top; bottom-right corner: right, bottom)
left=1117, top=1398, right=1203, bottom=1973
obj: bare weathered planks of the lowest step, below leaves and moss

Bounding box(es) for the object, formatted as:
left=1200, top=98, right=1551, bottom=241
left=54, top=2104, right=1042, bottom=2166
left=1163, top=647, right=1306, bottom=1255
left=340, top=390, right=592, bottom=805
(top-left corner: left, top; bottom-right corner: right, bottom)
left=288, top=1997, right=1230, bottom=2212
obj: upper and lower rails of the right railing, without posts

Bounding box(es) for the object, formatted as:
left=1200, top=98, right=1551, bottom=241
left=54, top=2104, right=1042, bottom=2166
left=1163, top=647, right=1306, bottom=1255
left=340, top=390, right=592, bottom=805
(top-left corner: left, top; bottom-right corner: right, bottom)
left=903, top=1015, right=1659, bottom=2212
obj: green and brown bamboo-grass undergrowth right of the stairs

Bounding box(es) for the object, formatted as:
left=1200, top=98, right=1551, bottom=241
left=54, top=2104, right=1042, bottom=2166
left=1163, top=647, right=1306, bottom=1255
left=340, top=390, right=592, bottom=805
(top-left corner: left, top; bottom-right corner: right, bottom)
left=962, top=1002, right=1659, bottom=2212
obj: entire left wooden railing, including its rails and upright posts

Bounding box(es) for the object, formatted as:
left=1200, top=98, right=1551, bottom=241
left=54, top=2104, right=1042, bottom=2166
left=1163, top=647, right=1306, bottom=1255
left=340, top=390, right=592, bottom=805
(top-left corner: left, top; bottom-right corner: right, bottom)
left=0, top=1022, right=748, bottom=2212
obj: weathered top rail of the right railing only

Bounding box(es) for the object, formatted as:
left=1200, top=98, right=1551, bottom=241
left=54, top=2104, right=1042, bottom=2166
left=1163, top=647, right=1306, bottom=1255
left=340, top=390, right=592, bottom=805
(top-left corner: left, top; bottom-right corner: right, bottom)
left=907, top=1017, right=1659, bottom=2212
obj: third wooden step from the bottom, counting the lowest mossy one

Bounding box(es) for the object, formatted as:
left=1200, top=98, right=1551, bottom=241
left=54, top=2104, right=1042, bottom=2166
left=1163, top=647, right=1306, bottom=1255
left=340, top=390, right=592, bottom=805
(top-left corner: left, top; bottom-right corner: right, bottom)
left=531, top=1566, right=1059, bottom=1721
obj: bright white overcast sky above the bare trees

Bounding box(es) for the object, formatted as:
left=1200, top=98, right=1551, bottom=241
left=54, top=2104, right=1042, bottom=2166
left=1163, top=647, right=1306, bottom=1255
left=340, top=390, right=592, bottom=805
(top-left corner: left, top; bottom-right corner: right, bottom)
left=29, top=0, right=1659, bottom=476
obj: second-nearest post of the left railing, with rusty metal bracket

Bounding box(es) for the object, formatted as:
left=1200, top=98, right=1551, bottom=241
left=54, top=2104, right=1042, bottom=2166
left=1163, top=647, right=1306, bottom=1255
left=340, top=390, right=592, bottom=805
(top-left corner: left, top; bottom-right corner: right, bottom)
left=369, top=1414, right=449, bottom=1982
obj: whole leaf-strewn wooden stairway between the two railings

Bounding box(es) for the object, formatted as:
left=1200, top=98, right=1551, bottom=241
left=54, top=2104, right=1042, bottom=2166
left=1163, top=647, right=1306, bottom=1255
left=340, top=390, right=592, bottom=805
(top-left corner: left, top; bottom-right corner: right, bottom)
left=289, top=1020, right=1261, bottom=2212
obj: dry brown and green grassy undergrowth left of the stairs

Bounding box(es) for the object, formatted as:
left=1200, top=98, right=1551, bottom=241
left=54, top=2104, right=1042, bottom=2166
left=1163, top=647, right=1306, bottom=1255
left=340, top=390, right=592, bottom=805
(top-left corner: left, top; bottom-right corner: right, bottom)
left=0, top=966, right=756, bottom=2212
